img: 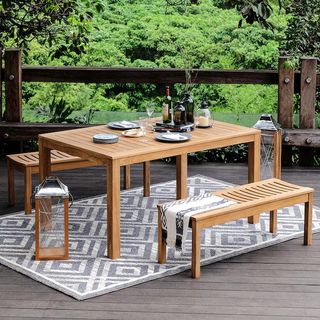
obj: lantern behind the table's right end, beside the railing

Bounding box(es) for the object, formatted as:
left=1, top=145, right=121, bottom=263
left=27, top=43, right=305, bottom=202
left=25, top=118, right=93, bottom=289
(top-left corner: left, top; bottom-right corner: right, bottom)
left=253, top=114, right=282, bottom=180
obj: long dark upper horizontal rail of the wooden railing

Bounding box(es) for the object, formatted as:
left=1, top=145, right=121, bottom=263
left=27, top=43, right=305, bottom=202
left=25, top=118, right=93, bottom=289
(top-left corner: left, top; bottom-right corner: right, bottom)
left=1, top=66, right=320, bottom=86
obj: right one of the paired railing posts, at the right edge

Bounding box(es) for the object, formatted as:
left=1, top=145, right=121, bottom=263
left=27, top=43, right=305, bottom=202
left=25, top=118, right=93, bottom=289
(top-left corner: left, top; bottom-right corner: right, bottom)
left=299, top=57, right=317, bottom=166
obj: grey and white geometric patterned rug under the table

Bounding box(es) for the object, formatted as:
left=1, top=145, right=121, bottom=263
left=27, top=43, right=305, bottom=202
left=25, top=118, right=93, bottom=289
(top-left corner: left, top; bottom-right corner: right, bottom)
left=0, top=175, right=320, bottom=300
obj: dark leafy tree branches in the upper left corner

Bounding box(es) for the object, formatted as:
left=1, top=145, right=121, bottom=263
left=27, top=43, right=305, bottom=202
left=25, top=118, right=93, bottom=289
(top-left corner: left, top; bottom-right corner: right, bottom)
left=0, top=0, right=102, bottom=58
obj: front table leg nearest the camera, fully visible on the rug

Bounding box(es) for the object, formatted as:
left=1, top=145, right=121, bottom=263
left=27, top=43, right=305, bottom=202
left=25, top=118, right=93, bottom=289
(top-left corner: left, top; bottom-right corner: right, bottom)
left=106, top=160, right=120, bottom=259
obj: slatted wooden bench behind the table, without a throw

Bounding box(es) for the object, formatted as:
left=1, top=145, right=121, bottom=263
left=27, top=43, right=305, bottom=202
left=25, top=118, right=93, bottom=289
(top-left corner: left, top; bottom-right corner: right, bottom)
left=7, top=150, right=146, bottom=214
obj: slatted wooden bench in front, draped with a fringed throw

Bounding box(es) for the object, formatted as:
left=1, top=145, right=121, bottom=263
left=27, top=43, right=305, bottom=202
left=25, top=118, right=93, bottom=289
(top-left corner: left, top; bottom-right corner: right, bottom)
left=158, top=179, right=314, bottom=278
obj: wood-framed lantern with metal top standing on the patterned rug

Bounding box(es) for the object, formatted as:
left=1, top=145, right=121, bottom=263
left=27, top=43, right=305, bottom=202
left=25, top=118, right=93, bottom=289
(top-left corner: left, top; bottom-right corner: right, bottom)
left=35, top=177, right=69, bottom=260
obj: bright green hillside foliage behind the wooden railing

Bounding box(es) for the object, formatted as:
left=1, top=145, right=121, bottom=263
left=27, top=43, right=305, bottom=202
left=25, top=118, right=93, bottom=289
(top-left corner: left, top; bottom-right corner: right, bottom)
left=19, top=0, right=288, bottom=122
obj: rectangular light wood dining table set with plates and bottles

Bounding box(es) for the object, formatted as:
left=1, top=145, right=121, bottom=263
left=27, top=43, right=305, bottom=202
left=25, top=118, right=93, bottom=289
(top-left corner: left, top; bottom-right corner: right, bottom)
left=39, top=121, right=260, bottom=259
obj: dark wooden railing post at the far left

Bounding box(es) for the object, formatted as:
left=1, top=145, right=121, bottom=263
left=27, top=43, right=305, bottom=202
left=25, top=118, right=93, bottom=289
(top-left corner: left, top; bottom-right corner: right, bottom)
left=4, top=49, right=22, bottom=122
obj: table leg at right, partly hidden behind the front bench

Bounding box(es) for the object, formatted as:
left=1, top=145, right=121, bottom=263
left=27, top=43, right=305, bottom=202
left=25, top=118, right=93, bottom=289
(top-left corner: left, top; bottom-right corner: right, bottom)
left=248, top=133, right=261, bottom=224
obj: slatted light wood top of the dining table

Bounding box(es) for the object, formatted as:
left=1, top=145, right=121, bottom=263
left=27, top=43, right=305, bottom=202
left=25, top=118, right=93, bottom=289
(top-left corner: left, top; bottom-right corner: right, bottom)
left=39, top=121, right=260, bottom=165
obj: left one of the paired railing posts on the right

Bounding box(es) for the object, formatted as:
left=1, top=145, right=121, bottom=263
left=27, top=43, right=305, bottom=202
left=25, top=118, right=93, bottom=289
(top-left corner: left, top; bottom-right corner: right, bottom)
left=278, top=57, right=294, bottom=166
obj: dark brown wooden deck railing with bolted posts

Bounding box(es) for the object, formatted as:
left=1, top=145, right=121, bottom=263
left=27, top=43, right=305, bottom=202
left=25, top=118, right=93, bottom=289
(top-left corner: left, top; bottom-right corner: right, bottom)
left=0, top=49, right=320, bottom=165
